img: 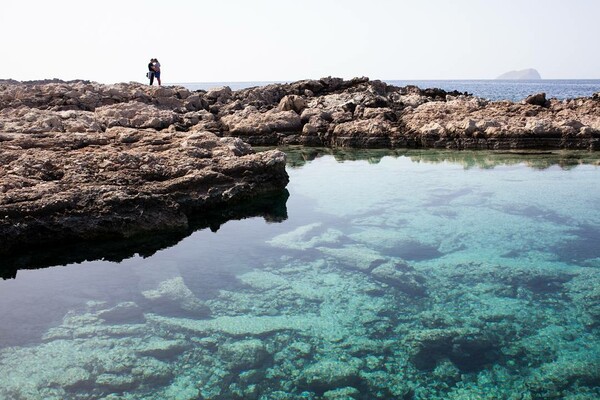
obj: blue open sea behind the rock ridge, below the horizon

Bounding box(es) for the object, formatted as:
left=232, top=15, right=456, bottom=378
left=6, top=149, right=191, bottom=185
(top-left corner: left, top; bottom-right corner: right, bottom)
left=179, top=79, right=600, bottom=101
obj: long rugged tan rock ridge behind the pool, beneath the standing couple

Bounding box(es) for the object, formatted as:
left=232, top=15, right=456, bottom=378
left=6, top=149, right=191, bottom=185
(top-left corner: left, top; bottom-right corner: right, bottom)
left=0, top=78, right=600, bottom=150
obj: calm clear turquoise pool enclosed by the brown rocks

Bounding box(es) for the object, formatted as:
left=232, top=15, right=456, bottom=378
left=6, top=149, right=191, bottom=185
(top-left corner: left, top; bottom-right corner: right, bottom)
left=0, top=149, right=600, bottom=399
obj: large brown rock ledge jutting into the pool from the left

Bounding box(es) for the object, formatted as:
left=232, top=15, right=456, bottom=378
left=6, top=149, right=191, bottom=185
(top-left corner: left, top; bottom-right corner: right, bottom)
left=0, top=127, right=288, bottom=252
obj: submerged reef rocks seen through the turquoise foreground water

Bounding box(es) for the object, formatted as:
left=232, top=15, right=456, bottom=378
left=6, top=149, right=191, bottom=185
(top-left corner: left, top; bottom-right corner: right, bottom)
left=0, top=218, right=600, bottom=400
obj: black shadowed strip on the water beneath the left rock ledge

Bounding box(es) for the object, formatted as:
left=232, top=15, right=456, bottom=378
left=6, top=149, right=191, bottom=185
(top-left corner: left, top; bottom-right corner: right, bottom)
left=0, top=190, right=289, bottom=279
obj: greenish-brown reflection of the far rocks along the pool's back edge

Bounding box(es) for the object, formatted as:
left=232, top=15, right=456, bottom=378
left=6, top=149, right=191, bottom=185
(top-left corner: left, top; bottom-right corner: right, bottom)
left=268, top=146, right=600, bottom=170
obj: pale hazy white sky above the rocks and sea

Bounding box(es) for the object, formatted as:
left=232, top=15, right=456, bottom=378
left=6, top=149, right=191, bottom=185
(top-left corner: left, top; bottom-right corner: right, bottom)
left=0, top=0, right=600, bottom=83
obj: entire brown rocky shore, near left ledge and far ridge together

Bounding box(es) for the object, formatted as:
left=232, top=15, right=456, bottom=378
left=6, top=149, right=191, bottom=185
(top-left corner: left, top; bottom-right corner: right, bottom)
left=0, top=78, right=600, bottom=253
